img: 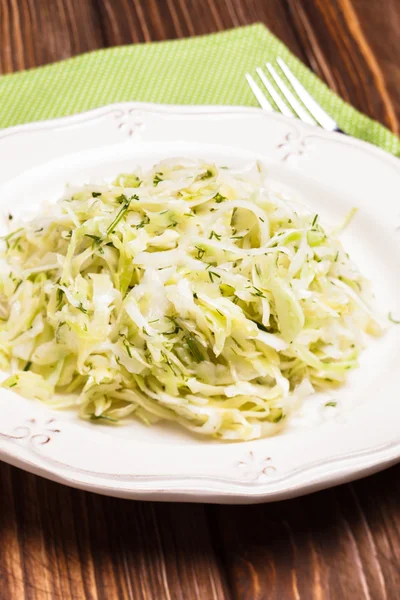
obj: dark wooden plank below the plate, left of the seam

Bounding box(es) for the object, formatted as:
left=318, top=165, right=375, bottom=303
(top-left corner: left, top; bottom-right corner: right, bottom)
left=0, top=464, right=230, bottom=600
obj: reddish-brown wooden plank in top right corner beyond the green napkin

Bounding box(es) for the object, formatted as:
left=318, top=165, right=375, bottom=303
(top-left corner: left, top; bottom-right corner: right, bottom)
left=288, top=0, right=400, bottom=133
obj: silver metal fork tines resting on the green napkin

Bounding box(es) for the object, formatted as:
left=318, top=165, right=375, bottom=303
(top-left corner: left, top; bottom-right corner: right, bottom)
left=246, top=58, right=345, bottom=133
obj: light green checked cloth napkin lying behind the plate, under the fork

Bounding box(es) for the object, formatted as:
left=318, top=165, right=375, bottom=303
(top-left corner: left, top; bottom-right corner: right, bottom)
left=0, top=24, right=400, bottom=156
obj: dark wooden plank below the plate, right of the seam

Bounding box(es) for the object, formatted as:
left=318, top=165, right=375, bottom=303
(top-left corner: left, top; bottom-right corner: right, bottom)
left=209, top=467, right=400, bottom=600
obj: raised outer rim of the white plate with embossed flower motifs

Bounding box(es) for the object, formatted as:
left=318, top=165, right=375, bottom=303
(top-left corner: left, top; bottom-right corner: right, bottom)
left=0, top=102, right=400, bottom=503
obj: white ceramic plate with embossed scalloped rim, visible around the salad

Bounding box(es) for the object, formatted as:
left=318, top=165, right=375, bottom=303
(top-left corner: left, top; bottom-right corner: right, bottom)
left=0, top=103, right=400, bottom=503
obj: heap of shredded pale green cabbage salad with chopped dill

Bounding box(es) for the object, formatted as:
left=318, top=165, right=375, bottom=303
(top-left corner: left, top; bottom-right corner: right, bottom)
left=0, top=159, right=380, bottom=440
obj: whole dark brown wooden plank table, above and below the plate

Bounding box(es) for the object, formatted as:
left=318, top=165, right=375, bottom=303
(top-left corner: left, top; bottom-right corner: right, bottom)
left=0, top=0, right=400, bottom=600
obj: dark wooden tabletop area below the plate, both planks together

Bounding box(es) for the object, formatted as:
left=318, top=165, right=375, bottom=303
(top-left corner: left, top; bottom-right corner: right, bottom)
left=0, top=465, right=400, bottom=600
